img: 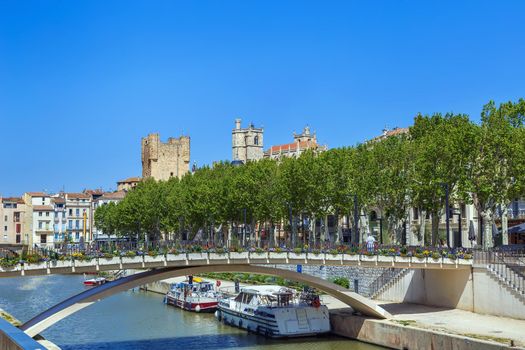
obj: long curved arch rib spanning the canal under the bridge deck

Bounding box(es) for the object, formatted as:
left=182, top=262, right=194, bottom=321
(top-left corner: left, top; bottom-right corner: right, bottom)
left=20, top=264, right=391, bottom=337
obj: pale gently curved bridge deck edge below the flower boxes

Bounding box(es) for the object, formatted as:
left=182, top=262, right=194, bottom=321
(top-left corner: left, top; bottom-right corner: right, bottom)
left=0, top=252, right=472, bottom=277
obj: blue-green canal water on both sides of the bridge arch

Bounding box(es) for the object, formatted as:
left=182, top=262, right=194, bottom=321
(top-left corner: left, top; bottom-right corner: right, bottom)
left=0, top=275, right=380, bottom=350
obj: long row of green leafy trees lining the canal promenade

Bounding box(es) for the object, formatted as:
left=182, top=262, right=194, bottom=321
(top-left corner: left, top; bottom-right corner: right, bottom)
left=95, top=99, right=525, bottom=244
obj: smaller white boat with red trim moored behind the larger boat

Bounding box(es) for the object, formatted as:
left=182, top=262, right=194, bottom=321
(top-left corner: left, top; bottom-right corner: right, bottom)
left=165, top=277, right=219, bottom=312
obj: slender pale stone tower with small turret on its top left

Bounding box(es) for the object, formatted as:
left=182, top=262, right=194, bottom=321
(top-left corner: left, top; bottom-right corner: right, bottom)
left=232, top=119, right=264, bottom=163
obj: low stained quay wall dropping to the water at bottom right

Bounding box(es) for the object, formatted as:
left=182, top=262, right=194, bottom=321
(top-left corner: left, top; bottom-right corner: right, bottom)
left=330, top=310, right=517, bottom=350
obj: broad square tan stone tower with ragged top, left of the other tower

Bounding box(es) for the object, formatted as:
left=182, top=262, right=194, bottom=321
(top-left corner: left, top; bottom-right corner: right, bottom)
left=142, top=134, right=190, bottom=180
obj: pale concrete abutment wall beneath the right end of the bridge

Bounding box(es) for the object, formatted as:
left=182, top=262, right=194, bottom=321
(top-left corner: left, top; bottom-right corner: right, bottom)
left=376, top=267, right=525, bottom=319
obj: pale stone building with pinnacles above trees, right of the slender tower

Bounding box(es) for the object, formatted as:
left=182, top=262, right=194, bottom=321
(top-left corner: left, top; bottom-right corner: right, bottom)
left=264, top=126, right=328, bottom=159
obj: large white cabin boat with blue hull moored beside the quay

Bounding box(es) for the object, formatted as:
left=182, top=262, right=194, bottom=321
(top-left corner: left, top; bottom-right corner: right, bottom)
left=215, top=286, right=330, bottom=338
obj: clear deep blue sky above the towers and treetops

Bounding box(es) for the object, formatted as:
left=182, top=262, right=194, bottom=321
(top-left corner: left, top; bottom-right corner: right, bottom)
left=0, top=0, right=525, bottom=196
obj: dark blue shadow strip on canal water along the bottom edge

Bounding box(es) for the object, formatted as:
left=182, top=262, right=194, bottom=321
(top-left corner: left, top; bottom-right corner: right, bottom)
left=60, top=334, right=353, bottom=350
